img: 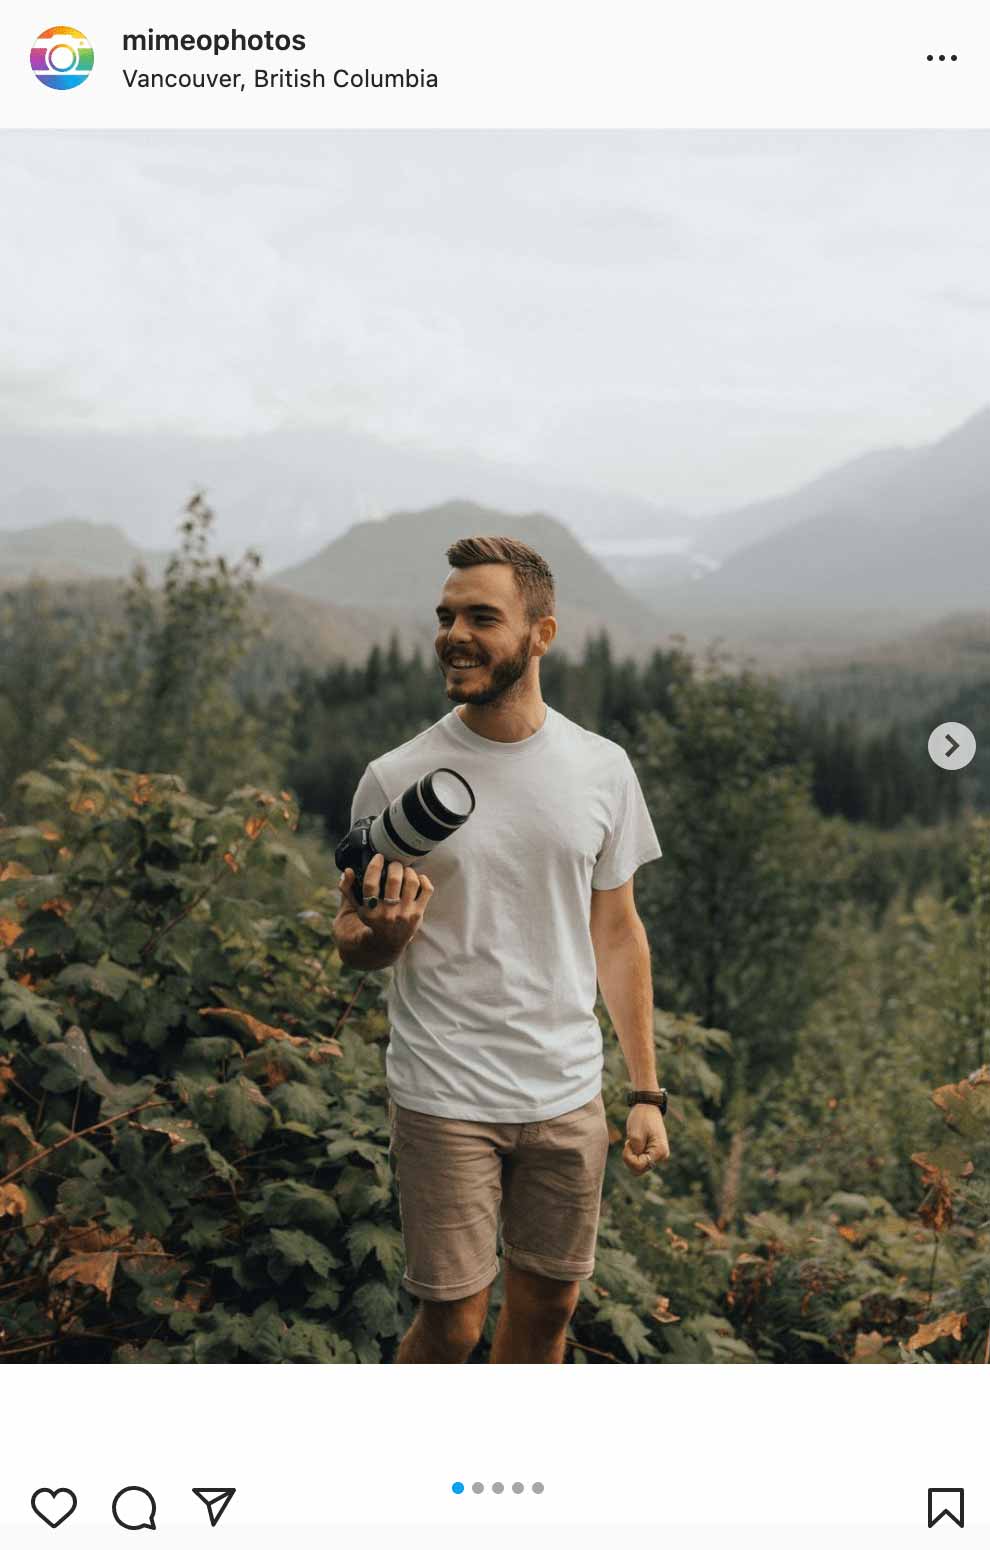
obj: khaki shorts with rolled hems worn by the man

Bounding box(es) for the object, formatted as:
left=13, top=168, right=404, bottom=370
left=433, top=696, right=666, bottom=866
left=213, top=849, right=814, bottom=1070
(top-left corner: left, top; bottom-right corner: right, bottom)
left=390, top=1096, right=609, bottom=1302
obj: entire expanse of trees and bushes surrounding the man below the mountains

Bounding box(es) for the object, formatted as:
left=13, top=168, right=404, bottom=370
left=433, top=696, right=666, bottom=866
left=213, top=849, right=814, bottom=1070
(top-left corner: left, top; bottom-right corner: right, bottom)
left=0, top=498, right=990, bottom=1364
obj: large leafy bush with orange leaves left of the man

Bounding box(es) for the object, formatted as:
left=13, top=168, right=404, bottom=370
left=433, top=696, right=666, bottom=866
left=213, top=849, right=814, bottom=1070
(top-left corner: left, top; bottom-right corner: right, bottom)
left=0, top=758, right=401, bottom=1361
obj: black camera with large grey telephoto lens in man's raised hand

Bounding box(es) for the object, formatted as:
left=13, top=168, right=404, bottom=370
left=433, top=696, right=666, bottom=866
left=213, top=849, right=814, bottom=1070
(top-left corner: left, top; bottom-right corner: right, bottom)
left=333, top=769, right=474, bottom=897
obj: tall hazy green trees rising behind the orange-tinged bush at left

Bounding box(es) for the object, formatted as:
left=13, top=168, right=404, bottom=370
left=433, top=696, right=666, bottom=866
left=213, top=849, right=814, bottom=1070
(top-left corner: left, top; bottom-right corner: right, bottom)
left=0, top=496, right=294, bottom=818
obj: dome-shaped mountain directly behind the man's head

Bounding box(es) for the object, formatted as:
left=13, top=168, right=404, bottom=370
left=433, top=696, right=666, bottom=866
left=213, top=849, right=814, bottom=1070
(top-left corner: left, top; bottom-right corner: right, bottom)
left=273, top=501, right=658, bottom=653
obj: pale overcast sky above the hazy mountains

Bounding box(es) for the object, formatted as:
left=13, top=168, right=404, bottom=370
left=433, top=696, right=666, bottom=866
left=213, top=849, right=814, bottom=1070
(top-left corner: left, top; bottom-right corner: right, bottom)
left=0, top=130, right=990, bottom=515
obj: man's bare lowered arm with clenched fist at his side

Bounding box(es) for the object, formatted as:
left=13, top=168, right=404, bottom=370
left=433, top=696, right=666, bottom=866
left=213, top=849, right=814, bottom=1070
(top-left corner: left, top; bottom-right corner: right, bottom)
left=590, top=877, right=671, bottom=1173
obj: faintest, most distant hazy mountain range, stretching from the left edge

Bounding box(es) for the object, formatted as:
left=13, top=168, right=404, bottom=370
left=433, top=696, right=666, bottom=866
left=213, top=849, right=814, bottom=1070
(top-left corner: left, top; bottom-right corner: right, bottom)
left=0, top=426, right=693, bottom=569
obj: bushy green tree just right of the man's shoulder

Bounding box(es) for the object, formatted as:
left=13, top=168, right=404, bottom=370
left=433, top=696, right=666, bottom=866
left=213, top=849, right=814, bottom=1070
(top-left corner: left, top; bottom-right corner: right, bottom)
left=638, top=659, right=838, bottom=1083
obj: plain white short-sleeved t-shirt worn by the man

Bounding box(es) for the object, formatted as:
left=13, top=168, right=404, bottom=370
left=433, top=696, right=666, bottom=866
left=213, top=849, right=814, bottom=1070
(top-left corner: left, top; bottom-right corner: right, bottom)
left=352, top=707, right=660, bottom=1124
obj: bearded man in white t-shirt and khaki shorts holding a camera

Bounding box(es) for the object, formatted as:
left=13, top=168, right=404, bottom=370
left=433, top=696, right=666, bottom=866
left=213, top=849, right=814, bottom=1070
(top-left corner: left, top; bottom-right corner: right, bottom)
left=335, top=538, right=669, bottom=1362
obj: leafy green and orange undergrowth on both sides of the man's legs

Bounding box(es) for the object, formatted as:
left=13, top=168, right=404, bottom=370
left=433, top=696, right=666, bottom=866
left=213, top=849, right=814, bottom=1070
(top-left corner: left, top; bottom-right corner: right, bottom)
left=0, top=756, right=990, bottom=1362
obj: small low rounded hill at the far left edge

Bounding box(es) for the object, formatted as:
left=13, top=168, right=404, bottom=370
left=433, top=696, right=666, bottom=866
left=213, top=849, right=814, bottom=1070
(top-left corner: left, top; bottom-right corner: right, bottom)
left=0, top=519, right=167, bottom=584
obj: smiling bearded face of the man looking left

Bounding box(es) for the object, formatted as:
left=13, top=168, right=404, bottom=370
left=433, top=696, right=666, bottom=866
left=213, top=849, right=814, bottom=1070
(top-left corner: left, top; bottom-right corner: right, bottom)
left=435, top=564, right=533, bottom=705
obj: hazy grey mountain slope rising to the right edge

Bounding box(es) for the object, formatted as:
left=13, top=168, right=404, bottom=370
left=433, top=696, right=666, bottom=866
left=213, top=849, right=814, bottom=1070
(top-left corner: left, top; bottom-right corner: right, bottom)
left=651, top=409, right=990, bottom=639
